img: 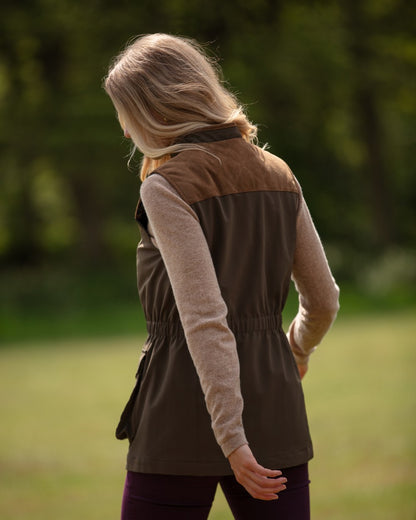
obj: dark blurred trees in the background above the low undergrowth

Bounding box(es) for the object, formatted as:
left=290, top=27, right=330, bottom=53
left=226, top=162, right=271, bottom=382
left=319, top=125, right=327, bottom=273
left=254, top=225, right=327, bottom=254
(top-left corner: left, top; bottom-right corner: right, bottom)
left=0, top=0, right=416, bottom=279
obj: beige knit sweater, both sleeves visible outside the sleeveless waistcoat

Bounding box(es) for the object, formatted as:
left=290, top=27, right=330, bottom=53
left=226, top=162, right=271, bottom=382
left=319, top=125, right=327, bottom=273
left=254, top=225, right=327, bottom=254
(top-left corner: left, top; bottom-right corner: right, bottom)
left=140, top=174, right=339, bottom=456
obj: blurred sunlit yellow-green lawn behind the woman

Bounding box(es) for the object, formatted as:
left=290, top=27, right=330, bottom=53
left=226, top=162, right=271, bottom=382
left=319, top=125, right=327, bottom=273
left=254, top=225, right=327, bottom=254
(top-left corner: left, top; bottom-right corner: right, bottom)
left=0, top=311, right=416, bottom=520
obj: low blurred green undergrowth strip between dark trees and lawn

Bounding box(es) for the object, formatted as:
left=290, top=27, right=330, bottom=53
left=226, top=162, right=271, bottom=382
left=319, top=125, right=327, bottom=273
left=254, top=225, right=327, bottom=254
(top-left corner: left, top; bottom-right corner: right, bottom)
left=0, top=264, right=416, bottom=349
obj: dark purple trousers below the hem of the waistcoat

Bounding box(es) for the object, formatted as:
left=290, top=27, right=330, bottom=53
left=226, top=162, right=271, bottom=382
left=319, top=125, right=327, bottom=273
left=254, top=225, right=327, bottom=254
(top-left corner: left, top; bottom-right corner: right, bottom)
left=121, top=464, right=310, bottom=520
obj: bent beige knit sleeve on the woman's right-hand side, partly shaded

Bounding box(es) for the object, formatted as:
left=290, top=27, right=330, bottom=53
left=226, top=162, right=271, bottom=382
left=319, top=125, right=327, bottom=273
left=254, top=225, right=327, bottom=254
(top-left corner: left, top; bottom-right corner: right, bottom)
left=288, top=194, right=339, bottom=364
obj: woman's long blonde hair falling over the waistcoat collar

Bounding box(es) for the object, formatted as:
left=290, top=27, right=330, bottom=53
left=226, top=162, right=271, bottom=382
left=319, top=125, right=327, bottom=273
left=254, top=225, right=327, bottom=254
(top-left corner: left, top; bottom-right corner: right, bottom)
left=104, top=33, right=257, bottom=180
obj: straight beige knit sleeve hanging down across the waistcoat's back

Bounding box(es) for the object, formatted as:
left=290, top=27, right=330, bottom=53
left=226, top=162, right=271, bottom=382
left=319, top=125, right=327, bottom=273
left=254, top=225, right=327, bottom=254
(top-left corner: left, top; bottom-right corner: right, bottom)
left=140, top=174, right=247, bottom=457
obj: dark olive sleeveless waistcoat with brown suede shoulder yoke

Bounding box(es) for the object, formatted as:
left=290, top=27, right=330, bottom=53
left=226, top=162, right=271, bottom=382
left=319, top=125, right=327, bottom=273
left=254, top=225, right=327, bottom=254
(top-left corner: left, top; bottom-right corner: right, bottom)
left=117, top=125, right=312, bottom=475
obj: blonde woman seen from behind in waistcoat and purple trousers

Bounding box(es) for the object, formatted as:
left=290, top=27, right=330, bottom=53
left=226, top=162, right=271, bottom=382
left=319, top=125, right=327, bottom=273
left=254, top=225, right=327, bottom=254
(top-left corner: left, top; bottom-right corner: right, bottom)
left=105, top=34, right=338, bottom=520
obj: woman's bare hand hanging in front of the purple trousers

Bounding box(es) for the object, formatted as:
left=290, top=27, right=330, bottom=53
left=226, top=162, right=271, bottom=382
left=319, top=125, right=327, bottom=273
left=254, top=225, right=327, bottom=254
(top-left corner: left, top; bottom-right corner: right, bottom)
left=228, top=444, right=287, bottom=500
